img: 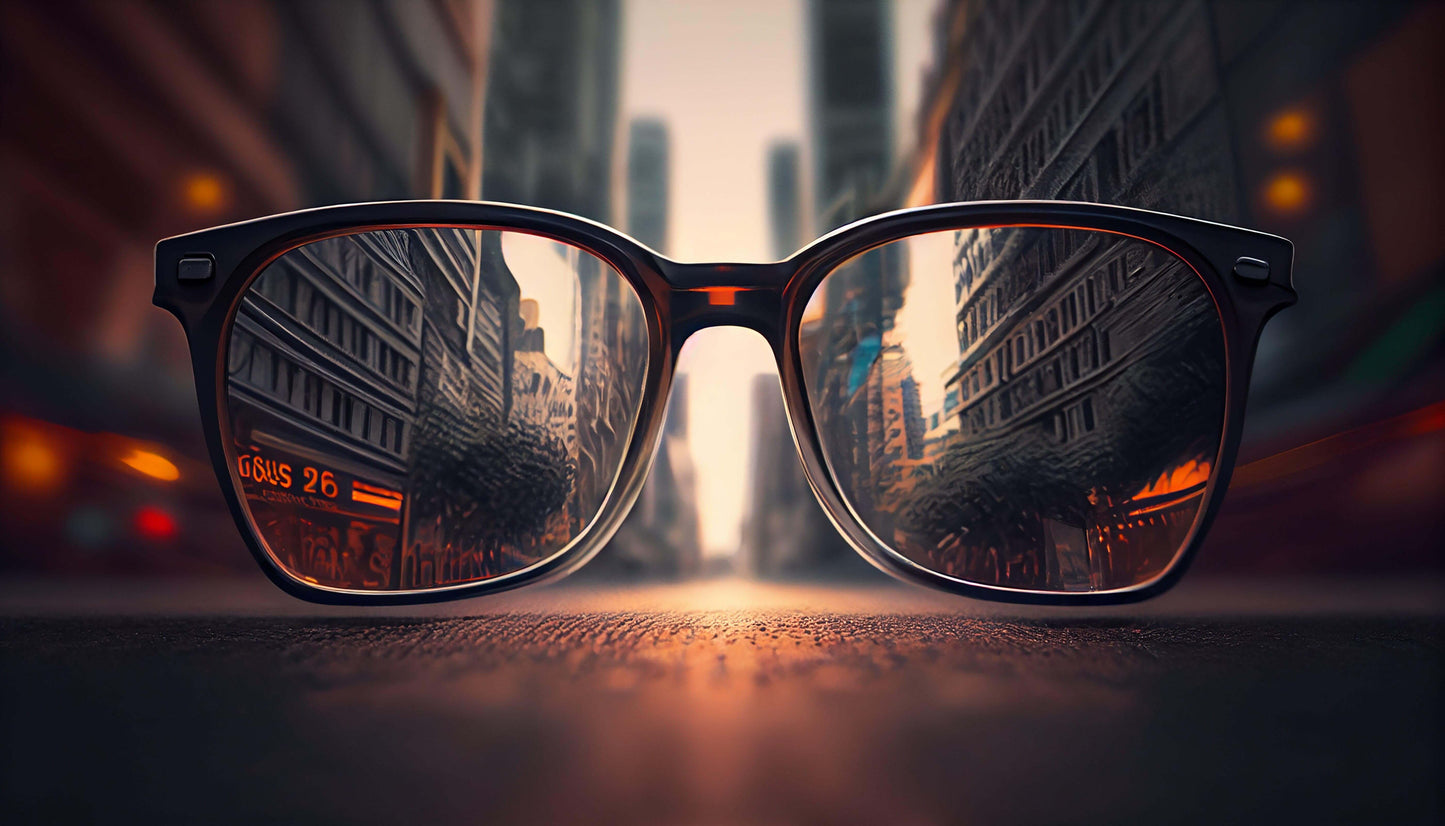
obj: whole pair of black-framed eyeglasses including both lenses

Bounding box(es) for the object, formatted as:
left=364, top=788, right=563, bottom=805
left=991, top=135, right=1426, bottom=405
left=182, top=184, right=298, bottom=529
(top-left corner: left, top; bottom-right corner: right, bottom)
left=155, top=201, right=1295, bottom=605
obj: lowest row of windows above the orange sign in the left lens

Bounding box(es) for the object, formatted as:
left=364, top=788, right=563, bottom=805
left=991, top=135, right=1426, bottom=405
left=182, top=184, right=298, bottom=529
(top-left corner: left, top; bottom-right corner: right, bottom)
left=228, top=331, right=407, bottom=458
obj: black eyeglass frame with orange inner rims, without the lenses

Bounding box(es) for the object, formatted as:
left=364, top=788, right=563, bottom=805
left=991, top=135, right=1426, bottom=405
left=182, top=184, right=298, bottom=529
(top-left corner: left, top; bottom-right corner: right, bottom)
left=155, top=201, right=1296, bottom=605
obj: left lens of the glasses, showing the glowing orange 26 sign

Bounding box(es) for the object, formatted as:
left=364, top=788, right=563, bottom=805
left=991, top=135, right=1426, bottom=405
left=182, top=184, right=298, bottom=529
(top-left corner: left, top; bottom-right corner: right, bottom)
left=227, top=228, right=647, bottom=591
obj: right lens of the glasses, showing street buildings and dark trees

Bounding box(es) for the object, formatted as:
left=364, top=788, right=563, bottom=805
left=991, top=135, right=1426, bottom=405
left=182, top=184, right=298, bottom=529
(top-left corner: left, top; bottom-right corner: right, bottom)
left=801, top=227, right=1225, bottom=591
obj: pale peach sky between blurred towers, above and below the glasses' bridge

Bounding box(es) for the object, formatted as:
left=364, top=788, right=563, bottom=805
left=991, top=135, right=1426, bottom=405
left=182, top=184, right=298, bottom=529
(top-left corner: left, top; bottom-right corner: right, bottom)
left=620, top=0, right=938, bottom=555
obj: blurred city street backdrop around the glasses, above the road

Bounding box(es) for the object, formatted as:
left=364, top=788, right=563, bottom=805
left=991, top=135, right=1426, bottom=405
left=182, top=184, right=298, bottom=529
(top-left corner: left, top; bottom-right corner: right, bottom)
left=0, top=0, right=1445, bottom=581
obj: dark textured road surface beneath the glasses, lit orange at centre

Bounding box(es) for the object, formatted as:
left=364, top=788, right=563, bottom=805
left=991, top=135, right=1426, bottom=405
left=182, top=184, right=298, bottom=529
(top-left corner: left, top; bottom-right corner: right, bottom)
left=0, top=582, right=1445, bottom=825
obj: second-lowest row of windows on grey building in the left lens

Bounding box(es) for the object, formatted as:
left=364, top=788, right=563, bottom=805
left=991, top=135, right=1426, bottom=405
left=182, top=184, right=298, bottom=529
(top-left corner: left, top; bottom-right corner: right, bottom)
left=251, top=264, right=416, bottom=390
